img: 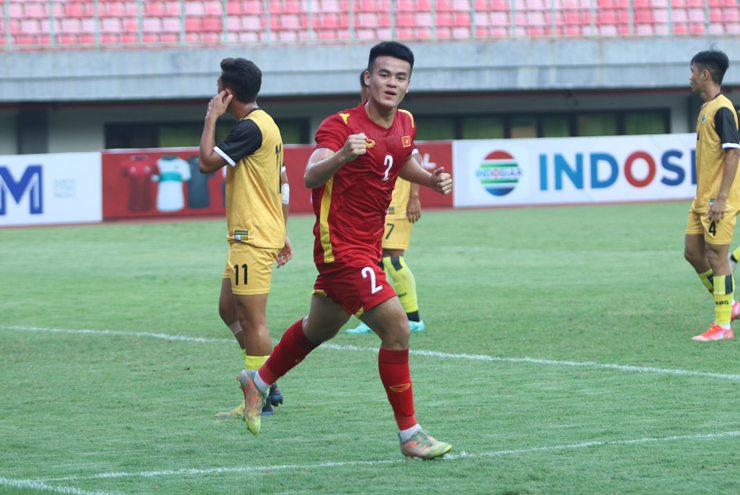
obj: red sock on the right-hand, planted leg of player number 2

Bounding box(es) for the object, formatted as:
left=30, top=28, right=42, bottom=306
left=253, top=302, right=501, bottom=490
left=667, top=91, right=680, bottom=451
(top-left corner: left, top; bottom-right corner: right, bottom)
left=378, top=349, right=416, bottom=430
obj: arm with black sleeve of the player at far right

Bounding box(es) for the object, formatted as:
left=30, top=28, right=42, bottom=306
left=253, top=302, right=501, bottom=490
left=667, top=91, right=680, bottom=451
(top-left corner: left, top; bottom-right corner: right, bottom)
left=707, top=107, right=740, bottom=222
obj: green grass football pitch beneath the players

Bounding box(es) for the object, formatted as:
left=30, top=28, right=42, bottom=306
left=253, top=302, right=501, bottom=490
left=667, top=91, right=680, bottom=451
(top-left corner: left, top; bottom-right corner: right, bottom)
left=0, top=202, right=740, bottom=495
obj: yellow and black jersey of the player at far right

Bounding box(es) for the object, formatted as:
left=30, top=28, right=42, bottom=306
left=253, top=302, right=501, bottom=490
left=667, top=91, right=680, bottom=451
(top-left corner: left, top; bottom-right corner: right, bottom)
left=691, top=93, right=740, bottom=213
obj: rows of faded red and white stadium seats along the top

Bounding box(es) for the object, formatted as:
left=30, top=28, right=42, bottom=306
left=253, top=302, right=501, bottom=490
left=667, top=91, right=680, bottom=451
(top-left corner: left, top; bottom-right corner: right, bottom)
left=0, top=0, right=740, bottom=49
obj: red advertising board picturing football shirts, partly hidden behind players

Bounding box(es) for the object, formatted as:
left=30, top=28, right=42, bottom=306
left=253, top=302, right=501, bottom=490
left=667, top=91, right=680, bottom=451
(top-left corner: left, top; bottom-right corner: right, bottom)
left=102, top=142, right=452, bottom=220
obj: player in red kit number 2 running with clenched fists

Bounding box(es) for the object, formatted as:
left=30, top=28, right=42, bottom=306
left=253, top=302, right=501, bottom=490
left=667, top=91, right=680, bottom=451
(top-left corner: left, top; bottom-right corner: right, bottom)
left=239, top=42, right=452, bottom=459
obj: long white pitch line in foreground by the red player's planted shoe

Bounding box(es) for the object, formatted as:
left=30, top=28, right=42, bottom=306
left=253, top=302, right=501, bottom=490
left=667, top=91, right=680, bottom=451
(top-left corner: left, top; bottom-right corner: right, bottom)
left=37, top=431, right=740, bottom=482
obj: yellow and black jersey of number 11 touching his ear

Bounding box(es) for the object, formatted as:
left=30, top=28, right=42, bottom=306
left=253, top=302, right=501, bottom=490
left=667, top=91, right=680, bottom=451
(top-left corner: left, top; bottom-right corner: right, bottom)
left=214, top=108, right=285, bottom=248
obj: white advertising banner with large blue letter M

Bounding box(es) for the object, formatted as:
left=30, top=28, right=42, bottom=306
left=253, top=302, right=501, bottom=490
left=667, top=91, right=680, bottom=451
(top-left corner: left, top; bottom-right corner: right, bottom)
left=0, top=153, right=102, bottom=226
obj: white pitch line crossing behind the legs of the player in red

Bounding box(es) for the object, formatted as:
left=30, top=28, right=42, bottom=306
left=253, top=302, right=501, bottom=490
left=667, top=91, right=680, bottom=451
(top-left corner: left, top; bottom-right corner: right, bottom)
left=0, top=325, right=740, bottom=381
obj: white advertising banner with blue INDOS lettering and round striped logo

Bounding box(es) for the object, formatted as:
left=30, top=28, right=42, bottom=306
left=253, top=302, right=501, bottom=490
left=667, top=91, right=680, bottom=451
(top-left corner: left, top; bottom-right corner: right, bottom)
left=453, top=134, right=696, bottom=207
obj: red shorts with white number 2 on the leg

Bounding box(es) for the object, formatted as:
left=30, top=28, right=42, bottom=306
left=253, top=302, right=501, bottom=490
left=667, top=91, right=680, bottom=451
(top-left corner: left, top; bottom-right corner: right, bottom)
left=313, top=259, right=396, bottom=318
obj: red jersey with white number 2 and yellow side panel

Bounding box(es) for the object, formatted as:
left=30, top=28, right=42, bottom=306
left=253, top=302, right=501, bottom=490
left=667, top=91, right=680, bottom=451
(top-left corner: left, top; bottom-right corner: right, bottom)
left=312, top=104, right=416, bottom=263
